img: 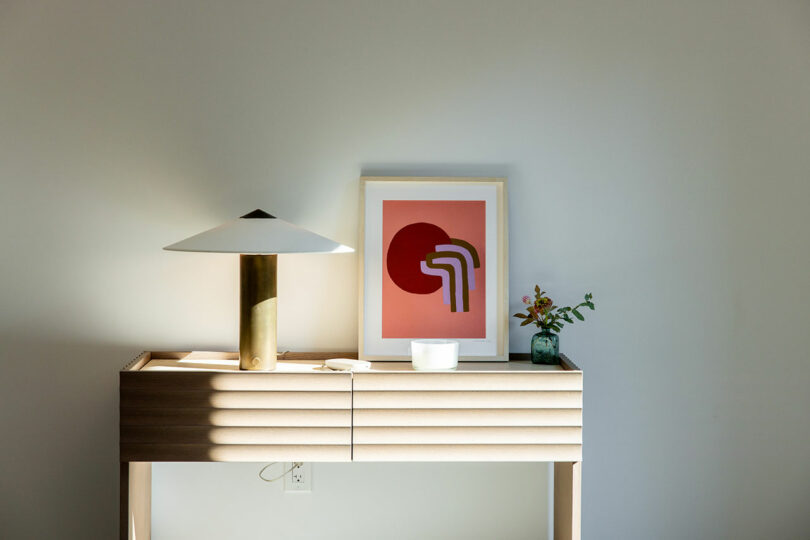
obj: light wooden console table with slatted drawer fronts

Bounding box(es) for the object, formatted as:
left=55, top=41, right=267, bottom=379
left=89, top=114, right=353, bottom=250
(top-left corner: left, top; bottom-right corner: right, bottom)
left=120, top=352, right=582, bottom=540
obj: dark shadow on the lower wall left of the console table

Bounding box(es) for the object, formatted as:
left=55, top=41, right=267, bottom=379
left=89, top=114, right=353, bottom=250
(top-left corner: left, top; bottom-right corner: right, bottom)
left=0, top=334, right=138, bottom=538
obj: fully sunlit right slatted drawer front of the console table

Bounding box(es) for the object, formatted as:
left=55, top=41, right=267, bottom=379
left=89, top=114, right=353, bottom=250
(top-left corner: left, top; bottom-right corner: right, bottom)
left=352, top=372, right=582, bottom=461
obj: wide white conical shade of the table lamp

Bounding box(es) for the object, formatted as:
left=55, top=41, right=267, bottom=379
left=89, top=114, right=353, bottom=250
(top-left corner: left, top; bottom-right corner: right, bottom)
left=163, top=210, right=354, bottom=255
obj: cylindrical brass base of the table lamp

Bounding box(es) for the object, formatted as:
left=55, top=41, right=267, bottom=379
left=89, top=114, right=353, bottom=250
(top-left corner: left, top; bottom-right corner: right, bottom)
left=239, top=255, right=278, bottom=371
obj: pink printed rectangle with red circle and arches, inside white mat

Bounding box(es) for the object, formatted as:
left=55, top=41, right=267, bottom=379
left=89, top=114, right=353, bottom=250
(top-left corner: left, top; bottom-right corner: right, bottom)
left=382, top=200, right=486, bottom=339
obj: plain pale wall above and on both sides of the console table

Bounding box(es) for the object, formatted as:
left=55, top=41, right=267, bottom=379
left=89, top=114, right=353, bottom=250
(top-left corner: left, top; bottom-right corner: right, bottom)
left=0, top=1, right=810, bottom=539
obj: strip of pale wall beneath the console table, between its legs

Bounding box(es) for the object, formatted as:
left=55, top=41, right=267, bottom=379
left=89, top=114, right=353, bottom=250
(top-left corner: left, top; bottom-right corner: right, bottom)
left=152, top=463, right=549, bottom=540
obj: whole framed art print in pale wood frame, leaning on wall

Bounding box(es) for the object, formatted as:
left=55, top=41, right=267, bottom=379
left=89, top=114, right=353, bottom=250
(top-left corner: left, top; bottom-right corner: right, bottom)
left=359, top=177, right=509, bottom=361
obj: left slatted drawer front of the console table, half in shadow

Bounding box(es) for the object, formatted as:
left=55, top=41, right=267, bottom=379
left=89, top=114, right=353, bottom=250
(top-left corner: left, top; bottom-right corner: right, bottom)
left=120, top=371, right=352, bottom=461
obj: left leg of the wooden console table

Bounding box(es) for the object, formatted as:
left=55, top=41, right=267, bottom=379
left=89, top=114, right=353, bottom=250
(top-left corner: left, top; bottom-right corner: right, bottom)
left=119, top=461, right=152, bottom=540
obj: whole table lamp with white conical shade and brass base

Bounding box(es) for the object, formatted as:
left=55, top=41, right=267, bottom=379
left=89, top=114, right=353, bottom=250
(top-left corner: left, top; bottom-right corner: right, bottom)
left=163, top=210, right=354, bottom=371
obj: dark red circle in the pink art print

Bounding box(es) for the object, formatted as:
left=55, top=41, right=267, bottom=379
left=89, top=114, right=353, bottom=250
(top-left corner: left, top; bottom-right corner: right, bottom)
left=386, top=223, right=450, bottom=294
